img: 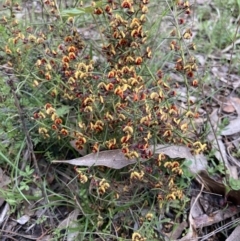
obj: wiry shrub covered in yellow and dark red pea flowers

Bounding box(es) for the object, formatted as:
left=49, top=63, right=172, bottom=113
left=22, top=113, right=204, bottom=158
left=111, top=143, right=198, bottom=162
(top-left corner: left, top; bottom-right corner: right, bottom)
left=2, top=0, right=206, bottom=240
